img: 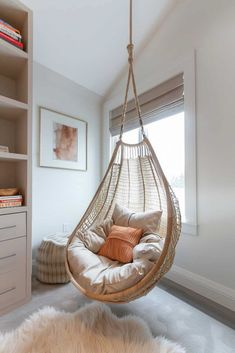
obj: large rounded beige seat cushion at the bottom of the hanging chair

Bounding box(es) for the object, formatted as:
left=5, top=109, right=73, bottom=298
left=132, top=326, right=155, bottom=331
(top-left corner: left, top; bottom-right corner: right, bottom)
left=68, top=238, right=153, bottom=294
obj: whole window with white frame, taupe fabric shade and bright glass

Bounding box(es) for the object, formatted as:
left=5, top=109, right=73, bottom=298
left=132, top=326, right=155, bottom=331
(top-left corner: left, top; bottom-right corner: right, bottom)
left=109, top=66, right=198, bottom=235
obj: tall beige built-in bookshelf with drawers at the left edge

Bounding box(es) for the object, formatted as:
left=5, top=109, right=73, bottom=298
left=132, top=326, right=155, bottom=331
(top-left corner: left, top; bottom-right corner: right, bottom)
left=0, top=0, right=33, bottom=314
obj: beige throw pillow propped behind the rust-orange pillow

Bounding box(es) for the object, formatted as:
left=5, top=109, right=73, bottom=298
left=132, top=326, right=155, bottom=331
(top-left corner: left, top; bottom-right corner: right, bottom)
left=112, top=204, right=162, bottom=234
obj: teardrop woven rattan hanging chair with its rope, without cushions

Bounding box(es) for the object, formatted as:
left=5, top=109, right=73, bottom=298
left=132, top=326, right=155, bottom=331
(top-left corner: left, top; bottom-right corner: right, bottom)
left=66, top=0, right=181, bottom=302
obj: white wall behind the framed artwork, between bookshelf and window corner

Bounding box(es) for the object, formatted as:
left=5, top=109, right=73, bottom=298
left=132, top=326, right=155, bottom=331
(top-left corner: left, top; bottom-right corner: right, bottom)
left=33, top=63, right=101, bottom=252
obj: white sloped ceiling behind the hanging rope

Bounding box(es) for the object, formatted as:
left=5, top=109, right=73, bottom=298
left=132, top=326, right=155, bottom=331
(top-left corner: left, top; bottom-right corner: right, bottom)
left=22, top=0, right=177, bottom=96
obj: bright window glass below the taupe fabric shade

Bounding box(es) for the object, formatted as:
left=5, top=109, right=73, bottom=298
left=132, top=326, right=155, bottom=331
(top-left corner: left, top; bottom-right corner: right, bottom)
left=112, top=112, right=185, bottom=220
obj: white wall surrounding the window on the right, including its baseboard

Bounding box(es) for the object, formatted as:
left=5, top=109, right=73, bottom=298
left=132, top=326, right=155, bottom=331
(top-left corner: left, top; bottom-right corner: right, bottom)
left=103, top=0, right=235, bottom=308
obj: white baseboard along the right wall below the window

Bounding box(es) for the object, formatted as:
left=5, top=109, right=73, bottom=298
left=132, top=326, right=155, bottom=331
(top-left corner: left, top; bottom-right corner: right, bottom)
left=166, top=265, right=235, bottom=310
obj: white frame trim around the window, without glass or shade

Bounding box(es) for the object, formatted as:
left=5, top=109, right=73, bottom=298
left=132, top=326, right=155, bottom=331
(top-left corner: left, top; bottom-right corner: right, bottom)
left=102, top=51, right=198, bottom=235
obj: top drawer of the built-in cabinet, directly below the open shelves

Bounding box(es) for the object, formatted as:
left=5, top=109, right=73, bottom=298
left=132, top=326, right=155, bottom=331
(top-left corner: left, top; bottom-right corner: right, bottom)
left=0, top=212, right=26, bottom=241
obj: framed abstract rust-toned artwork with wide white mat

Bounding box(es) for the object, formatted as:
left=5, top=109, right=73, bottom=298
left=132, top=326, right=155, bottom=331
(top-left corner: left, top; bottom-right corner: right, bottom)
left=40, top=107, right=87, bottom=171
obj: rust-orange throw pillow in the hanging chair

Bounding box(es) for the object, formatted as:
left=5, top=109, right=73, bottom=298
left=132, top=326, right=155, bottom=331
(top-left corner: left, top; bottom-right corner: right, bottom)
left=98, top=225, right=143, bottom=263
